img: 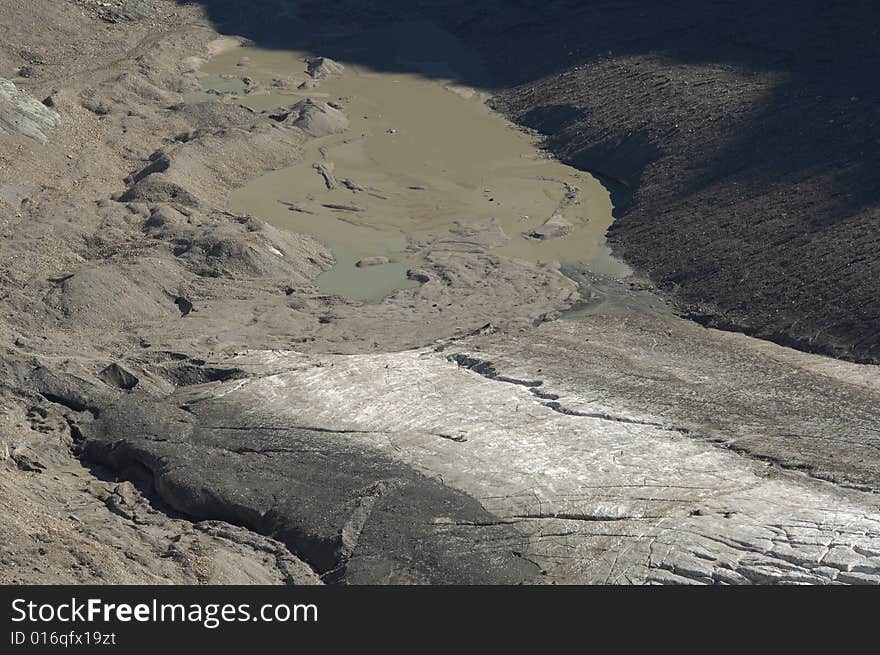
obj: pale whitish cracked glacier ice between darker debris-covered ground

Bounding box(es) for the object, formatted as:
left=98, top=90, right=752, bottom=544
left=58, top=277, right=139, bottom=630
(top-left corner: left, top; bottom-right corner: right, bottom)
left=198, top=350, right=880, bottom=583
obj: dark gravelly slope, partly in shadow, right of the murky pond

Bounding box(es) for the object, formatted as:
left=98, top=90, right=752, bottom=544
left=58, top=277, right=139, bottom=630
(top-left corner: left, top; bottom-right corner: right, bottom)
left=460, top=0, right=880, bottom=363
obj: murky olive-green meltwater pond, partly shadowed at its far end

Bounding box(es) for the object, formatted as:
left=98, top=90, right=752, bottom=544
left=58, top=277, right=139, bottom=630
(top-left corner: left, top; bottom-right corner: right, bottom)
left=188, top=27, right=629, bottom=301
